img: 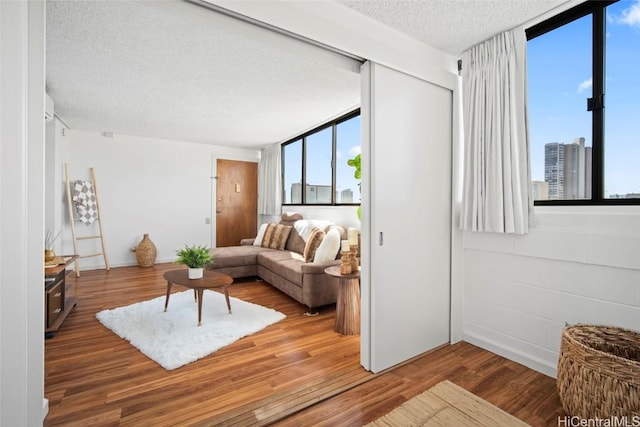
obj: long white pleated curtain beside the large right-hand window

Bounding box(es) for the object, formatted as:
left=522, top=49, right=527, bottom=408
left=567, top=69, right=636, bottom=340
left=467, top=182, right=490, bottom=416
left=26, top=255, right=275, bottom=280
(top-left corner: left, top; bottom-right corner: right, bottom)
left=461, top=28, right=533, bottom=234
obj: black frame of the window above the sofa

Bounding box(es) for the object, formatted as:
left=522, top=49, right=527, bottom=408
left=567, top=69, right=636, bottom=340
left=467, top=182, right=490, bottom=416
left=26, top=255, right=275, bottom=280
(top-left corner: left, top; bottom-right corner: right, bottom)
left=280, top=108, right=360, bottom=206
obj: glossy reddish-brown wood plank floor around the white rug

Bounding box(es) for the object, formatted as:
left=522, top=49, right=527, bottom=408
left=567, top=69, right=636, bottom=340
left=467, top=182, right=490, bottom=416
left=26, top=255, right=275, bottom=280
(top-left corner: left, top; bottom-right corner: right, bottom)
left=44, top=264, right=563, bottom=426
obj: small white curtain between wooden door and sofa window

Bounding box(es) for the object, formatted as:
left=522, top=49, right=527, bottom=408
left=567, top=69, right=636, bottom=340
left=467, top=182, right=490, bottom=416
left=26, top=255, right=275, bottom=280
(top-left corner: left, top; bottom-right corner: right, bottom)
left=258, top=144, right=282, bottom=216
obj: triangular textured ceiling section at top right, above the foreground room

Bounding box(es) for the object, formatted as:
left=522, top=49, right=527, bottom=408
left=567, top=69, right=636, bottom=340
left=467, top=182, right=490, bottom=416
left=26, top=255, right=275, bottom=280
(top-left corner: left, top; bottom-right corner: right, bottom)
left=338, top=0, right=567, bottom=56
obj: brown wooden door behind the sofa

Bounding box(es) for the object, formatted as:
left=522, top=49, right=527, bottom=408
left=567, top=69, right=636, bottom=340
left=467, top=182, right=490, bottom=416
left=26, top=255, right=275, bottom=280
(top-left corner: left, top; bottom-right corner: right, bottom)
left=216, top=159, right=258, bottom=247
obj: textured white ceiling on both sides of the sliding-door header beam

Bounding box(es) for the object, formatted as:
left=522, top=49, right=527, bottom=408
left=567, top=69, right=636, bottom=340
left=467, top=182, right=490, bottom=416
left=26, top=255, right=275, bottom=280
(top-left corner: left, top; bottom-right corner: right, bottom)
left=46, top=0, right=565, bottom=148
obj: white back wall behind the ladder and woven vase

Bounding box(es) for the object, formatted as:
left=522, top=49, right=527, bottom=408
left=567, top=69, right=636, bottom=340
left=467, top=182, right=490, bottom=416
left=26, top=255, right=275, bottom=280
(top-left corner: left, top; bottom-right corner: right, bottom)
left=47, top=127, right=260, bottom=270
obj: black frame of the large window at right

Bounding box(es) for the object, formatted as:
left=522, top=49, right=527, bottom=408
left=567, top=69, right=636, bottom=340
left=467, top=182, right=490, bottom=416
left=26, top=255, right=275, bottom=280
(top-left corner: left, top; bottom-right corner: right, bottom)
left=525, top=0, right=640, bottom=206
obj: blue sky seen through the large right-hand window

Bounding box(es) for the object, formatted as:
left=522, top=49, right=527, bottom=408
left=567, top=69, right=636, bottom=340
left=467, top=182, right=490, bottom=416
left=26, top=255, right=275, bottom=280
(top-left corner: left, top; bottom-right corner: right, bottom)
left=527, top=0, right=640, bottom=195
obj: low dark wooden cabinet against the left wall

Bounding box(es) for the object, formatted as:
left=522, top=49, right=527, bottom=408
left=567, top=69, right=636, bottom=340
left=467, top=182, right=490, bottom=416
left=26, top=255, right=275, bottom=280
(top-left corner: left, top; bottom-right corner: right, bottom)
left=44, top=255, right=78, bottom=338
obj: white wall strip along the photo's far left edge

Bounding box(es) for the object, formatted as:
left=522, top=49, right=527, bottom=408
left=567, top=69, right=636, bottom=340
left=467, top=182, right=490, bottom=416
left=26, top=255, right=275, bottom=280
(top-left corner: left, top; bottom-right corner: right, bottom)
left=0, top=1, right=47, bottom=426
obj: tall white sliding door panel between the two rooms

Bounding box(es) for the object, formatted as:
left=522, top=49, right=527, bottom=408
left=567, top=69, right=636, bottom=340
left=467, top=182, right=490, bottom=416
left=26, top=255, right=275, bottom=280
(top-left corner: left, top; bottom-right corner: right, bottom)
left=361, top=63, right=452, bottom=372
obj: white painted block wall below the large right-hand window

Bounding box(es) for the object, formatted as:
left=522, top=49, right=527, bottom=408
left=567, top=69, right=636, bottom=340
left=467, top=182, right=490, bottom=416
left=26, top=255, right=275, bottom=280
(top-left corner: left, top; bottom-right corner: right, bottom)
left=464, top=206, right=640, bottom=377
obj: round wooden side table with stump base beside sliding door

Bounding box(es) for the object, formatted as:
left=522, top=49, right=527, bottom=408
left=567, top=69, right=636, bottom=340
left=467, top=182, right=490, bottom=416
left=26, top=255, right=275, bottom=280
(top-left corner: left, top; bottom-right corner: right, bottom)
left=324, top=265, right=360, bottom=335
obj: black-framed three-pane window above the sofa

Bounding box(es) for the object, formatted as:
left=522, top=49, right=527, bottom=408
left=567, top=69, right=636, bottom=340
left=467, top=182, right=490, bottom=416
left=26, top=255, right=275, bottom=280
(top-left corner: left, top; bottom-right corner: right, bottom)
left=282, top=110, right=360, bottom=205
